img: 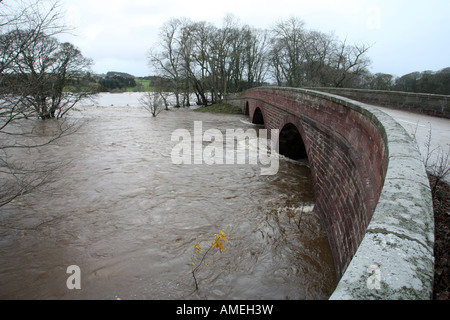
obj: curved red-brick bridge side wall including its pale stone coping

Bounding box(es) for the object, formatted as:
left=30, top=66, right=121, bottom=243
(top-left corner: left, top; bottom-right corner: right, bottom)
left=240, top=87, right=434, bottom=299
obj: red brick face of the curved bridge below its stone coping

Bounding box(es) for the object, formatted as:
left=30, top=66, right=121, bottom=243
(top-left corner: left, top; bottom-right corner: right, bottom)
left=241, top=88, right=388, bottom=278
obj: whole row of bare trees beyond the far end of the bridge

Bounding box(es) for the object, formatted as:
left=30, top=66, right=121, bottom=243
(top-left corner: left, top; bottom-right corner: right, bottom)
left=148, top=15, right=370, bottom=106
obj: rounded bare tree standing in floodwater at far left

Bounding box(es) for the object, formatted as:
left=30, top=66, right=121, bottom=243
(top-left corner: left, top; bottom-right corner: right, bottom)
left=5, top=34, right=92, bottom=119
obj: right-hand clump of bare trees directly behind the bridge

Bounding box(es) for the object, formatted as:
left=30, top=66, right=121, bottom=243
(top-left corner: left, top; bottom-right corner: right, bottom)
left=270, top=17, right=370, bottom=87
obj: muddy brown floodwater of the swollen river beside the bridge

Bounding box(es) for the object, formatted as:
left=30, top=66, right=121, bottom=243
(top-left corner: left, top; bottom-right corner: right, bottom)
left=0, top=95, right=336, bottom=299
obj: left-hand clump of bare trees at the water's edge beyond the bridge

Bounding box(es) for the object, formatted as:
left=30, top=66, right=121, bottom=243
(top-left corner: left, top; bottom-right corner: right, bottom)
left=149, top=15, right=268, bottom=106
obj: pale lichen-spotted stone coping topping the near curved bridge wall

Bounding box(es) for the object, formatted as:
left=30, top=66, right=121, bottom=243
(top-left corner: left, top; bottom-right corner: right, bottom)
left=244, top=87, right=434, bottom=300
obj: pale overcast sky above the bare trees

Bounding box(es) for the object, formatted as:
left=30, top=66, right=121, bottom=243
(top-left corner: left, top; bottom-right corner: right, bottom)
left=62, top=0, right=450, bottom=76
